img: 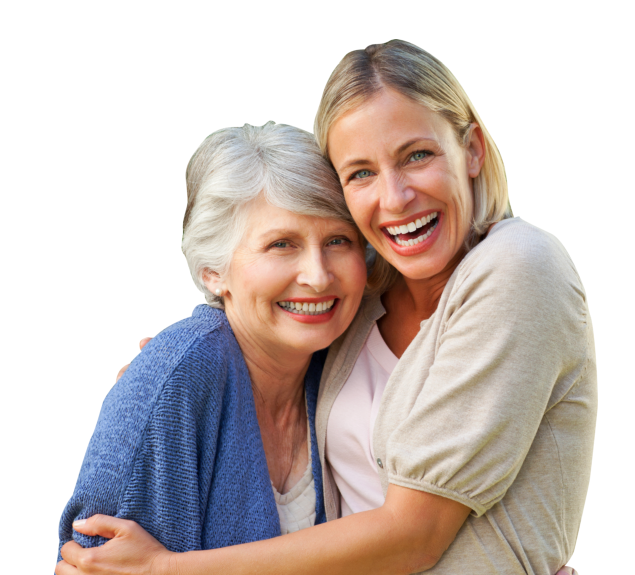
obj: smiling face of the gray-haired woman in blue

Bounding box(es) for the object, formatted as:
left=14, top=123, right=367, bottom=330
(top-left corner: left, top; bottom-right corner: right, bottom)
left=212, top=197, right=366, bottom=360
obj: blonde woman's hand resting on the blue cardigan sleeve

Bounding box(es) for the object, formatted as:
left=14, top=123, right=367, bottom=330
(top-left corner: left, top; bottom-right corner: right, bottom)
left=55, top=515, right=177, bottom=575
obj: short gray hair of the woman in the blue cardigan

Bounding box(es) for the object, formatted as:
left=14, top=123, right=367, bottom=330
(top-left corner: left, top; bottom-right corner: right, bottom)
left=181, top=121, right=361, bottom=309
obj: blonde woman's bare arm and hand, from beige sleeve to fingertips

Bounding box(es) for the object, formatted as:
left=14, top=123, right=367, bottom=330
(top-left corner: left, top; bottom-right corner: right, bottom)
left=56, top=485, right=470, bottom=575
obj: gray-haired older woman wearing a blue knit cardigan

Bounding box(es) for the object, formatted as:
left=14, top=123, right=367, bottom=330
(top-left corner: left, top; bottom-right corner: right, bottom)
left=58, top=123, right=366, bottom=561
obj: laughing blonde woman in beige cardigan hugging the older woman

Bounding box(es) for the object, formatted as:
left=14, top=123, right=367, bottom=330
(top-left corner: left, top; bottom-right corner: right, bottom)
left=60, top=41, right=597, bottom=575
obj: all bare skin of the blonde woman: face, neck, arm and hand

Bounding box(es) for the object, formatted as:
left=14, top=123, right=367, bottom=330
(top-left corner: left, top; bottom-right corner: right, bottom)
left=57, top=95, right=573, bottom=575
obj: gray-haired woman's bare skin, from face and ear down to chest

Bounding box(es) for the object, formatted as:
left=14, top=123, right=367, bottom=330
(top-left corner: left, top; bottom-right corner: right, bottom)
left=205, top=197, right=366, bottom=493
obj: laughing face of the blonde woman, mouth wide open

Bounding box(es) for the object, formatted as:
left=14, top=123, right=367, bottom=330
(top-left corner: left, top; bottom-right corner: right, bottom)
left=328, top=90, right=484, bottom=280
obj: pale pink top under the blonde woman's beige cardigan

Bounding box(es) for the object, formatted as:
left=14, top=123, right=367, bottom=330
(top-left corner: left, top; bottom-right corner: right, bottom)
left=326, top=324, right=399, bottom=517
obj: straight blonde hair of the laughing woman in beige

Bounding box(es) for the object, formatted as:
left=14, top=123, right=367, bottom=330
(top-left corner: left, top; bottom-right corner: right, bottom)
left=313, top=40, right=512, bottom=293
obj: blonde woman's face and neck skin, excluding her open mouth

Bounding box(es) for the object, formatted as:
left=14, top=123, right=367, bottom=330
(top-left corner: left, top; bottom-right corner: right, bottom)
left=328, top=90, right=485, bottom=357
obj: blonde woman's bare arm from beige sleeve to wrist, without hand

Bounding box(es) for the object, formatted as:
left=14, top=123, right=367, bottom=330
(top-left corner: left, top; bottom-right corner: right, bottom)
left=175, top=485, right=470, bottom=575
